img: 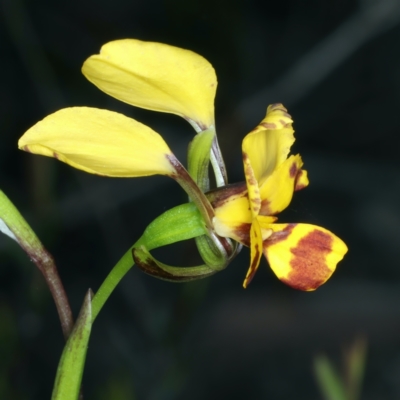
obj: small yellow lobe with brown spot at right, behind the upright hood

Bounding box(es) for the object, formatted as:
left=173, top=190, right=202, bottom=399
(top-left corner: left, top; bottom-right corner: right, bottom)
left=260, top=155, right=308, bottom=215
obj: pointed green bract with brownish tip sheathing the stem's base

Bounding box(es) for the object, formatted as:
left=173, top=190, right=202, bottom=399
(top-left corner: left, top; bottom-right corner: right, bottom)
left=51, top=289, right=93, bottom=400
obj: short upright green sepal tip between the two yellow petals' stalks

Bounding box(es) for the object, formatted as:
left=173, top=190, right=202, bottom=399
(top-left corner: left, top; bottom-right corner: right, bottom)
left=188, top=129, right=215, bottom=192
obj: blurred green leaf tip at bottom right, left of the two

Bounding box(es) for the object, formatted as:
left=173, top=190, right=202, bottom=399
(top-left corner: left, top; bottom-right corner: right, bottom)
left=314, top=355, right=348, bottom=400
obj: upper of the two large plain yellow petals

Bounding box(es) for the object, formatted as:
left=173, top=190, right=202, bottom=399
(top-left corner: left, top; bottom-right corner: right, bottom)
left=82, top=39, right=217, bottom=130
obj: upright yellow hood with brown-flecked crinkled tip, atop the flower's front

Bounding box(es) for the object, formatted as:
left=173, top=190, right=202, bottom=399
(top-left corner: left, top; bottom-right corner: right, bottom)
left=242, top=104, right=294, bottom=185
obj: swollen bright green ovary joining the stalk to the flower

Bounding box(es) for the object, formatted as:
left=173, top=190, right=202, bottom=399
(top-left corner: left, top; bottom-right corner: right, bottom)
left=135, top=203, right=207, bottom=250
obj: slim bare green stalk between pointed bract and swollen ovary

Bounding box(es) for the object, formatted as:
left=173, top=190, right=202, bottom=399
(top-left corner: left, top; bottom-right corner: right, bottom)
left=92, top=243, right=136, bottom=322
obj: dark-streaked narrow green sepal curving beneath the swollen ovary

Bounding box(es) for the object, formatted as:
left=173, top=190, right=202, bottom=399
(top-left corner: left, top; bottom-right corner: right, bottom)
left=132, top=246, right=217, bottom=282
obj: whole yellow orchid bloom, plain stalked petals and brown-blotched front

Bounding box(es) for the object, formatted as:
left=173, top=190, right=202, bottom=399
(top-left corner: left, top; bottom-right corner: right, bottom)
left=18, top=39, right=347, bottom=290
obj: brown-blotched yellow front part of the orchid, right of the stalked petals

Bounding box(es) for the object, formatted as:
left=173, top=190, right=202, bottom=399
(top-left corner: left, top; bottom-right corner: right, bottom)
left=210, top=104, right=347, bottom=290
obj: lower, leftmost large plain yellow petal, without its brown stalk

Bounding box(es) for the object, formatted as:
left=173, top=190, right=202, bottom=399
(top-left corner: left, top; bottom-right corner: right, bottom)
left=18, top=107, right=175, bottom=177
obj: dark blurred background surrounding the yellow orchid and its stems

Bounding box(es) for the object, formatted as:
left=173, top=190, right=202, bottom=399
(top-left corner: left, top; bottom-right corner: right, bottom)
left=0, top=0, right=400, bottom=400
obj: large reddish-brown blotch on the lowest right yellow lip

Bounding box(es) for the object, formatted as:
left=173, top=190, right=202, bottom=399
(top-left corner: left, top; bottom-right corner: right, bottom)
left=282, top=229, right=333, bottom=290
